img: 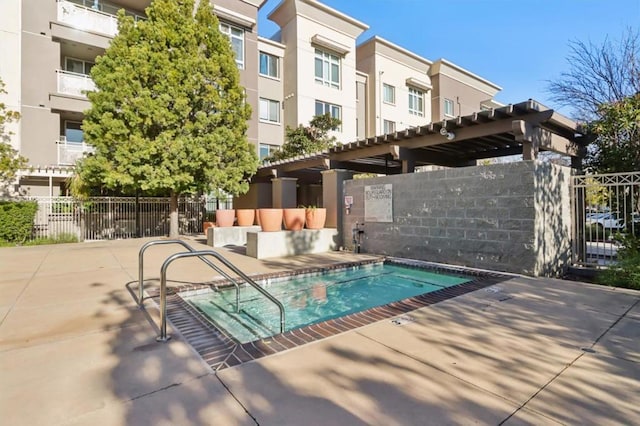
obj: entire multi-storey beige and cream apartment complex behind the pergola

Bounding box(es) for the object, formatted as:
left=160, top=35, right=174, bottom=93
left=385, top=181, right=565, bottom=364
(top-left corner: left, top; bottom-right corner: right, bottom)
left=0, top=0, right=500, bottom=195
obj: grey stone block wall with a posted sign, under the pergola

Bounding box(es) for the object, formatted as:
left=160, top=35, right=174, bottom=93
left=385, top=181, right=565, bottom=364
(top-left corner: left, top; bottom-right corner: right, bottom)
left=342, top=161, right=571, bottom=276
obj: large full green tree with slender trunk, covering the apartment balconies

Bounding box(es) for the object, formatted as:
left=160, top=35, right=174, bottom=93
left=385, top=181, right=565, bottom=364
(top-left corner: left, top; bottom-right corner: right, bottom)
left=78, top=0, right=258, bottom=237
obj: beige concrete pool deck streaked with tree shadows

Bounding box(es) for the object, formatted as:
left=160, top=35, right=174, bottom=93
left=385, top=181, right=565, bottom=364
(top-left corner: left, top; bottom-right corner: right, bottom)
left=0, top=240, right=640, bottom=426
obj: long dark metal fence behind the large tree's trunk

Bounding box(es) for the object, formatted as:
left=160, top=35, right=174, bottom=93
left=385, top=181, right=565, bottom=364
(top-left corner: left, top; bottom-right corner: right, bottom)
left=29, top=197, right=233, bottom=241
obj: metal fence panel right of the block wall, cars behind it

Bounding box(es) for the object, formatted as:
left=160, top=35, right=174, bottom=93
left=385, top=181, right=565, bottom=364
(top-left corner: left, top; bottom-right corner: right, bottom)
left=572, top=172, right=640, bottom=267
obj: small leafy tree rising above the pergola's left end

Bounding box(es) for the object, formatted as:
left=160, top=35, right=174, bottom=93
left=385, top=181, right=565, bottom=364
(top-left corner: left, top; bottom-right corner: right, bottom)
left=265, top=114, right=341, bottom=161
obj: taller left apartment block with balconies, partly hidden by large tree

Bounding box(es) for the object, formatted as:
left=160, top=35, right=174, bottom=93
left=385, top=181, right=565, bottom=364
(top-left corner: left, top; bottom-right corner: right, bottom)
left=0, top=0, right=265, bottom=195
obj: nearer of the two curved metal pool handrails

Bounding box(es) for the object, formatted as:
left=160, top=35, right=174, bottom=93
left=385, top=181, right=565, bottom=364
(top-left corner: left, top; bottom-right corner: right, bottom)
left=156, top=250, right=285, bottom=342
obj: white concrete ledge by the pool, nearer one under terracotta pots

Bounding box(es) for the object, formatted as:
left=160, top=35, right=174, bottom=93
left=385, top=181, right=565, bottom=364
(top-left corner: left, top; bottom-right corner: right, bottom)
left=247, top=228, right=338, bottom=259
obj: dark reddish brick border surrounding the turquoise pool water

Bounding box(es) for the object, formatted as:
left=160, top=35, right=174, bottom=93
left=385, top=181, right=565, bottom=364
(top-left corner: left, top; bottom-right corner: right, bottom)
left=150, top=256, right=511, bottom=371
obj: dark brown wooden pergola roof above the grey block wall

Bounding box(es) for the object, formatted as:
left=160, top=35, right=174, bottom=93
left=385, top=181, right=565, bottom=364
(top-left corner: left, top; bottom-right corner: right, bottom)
left=253, top=100, right=588, bottom=183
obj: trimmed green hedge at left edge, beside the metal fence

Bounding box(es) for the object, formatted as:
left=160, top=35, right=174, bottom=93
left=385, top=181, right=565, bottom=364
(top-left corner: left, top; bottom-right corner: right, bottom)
left=0, top=201, right=38, bottom=243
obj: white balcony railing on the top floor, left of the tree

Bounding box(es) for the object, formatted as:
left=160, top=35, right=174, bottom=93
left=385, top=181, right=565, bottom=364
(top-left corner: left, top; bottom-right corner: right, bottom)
left=58, top=0, right=118, bottom=37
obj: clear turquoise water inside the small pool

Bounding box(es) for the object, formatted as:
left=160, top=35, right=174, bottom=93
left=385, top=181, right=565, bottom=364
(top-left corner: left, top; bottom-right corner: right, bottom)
left=181, top=264, right=470, bottom=343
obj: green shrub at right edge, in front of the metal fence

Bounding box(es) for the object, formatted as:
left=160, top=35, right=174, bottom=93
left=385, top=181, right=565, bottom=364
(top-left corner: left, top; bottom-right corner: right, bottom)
left=597, top=235, right=640, bottom=290
